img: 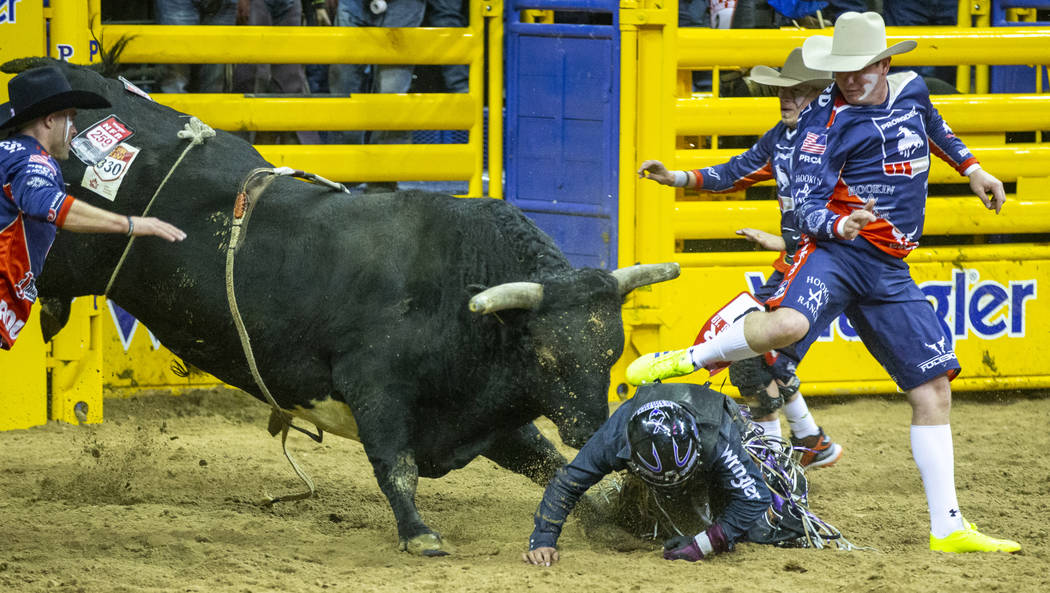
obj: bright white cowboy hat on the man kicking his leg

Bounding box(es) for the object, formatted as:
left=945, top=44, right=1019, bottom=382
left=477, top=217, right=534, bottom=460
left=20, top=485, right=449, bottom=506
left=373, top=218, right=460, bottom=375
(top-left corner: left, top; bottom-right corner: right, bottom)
left=802, top=12, right=918, bottom=72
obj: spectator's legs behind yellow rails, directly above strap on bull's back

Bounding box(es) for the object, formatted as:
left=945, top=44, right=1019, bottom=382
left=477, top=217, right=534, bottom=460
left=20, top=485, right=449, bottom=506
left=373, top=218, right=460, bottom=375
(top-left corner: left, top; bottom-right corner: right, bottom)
left=233, top=0, right=320, bottom=144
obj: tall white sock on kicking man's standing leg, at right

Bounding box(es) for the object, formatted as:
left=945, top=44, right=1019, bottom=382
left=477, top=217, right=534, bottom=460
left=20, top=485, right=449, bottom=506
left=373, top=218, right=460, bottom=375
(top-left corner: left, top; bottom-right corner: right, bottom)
left=911, top=424, right=964, bottom=537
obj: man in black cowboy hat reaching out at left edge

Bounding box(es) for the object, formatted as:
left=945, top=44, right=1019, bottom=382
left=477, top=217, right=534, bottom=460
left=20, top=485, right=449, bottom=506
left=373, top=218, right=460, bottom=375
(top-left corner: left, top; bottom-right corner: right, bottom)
left=0, top=67, right=186, bottom=350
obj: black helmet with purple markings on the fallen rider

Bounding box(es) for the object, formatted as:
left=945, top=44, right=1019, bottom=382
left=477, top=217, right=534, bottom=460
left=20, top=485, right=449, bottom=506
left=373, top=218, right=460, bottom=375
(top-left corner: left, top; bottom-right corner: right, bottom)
left=627, top=400, right=700, bottom=488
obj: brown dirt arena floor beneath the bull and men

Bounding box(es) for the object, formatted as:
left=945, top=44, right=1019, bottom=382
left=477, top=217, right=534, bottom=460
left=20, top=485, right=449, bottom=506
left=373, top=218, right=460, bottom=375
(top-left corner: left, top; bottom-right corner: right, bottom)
left=0, top=390, right=1050, bottom=593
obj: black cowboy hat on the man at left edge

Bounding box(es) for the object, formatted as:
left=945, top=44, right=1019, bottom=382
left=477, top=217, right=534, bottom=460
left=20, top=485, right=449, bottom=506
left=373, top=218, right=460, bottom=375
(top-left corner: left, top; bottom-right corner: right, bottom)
left=0, top=66, right=109, bottom=130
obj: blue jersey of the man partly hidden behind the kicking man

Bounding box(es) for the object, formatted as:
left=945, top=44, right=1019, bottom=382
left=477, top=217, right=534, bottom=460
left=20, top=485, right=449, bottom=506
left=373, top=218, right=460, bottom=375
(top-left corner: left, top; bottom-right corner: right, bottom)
left=693, top=122, right=800, bottom=273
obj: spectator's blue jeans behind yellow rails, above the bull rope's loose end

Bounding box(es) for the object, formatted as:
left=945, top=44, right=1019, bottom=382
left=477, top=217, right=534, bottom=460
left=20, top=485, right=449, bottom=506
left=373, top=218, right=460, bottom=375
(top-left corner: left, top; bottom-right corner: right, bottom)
left=329, top=0, right=426, bottom=144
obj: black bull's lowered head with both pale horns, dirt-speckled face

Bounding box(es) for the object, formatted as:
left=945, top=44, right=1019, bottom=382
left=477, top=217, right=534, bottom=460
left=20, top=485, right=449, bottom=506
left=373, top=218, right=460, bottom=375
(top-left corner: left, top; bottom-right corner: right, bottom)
left=469, top=263, right=679, bottom=447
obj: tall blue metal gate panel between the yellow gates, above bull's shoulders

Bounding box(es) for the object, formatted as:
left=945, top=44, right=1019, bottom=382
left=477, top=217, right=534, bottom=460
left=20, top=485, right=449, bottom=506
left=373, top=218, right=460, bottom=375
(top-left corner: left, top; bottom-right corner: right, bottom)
left=504, top=6, right=620, bottom=268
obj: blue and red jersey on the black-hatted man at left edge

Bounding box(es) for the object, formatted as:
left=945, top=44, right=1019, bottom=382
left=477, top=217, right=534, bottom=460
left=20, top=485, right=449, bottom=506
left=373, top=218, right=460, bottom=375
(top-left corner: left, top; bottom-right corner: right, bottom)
left=0, top=135, right=74, bottom=350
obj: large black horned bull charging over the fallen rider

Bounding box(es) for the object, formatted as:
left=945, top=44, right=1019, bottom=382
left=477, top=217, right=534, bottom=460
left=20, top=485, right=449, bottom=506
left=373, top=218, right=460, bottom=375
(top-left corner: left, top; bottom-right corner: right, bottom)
left=22, top=57, right=677, bottom=554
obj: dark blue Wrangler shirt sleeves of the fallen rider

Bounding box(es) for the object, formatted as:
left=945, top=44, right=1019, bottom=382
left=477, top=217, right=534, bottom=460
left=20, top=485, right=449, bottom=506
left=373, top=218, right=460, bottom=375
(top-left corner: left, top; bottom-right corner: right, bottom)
left=529, top=393, right=771, bottom=550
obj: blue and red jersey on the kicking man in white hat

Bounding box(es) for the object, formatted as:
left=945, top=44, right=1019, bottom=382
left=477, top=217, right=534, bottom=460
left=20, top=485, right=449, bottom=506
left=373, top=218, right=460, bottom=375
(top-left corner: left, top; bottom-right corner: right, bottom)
left=792, top=71, right=978, bottom=258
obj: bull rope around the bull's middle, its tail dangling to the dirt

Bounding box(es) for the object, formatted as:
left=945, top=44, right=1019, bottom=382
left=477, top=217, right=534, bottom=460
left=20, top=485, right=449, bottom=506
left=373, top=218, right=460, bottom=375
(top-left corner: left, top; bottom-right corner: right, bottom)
left=226, top=167, right=350, bottom=506
